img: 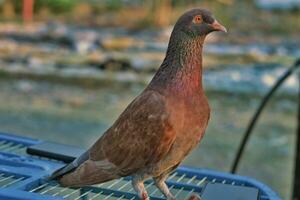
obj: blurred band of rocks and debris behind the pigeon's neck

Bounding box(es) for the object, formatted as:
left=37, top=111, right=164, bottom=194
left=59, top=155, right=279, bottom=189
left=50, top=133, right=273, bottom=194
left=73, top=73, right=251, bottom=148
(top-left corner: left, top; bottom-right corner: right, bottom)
left=0, top=23, right=300, bottom=94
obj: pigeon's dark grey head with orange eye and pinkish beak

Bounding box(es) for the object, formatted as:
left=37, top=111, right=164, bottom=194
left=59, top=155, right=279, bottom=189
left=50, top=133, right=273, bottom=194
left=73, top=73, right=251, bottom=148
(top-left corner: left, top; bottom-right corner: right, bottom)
left=174, top=9, right=227, bottom=37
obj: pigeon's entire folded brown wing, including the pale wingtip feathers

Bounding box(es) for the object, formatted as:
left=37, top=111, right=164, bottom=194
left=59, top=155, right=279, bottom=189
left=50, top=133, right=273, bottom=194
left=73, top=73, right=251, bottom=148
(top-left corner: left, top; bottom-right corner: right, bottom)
left=56, top=91, right=176, bottom=186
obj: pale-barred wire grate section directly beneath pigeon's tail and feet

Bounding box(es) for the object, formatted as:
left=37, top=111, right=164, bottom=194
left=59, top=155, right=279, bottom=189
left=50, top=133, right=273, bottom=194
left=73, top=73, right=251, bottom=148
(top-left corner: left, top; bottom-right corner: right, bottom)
left=30, top=172, right=207, bottom=199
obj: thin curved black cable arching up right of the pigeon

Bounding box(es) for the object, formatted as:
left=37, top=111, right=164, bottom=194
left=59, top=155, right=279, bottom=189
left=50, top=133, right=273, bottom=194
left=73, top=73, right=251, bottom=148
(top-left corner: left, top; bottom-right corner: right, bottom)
left=231, top=58, right=300, bottom=173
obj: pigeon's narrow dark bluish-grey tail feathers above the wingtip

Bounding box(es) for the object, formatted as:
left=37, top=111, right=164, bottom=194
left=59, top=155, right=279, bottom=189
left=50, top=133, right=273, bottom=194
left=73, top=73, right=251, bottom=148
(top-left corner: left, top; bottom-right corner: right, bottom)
left=48, top=151, right=89, bottom=180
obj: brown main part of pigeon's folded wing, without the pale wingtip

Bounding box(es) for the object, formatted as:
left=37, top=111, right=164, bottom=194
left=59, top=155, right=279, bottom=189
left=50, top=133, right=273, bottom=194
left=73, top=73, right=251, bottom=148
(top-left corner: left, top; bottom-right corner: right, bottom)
left=90, top=90, right=176, bottom=175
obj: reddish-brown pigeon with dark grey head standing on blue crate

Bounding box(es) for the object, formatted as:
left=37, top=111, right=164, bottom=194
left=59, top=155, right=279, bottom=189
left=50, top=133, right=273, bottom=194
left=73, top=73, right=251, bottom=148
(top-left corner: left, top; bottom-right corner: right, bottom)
left=51, top=9, right=227, bottom=200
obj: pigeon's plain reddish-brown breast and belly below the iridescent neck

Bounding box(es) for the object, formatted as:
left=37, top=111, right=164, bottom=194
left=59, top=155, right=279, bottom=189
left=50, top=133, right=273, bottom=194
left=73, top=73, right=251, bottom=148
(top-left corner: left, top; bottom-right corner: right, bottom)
left=149, top=93, right=210, bottom=175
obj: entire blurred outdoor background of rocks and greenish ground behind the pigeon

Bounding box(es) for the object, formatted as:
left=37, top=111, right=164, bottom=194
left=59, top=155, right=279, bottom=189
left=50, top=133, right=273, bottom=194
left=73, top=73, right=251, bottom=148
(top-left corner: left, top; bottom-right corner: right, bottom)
left=0, top=0, right=300, bottom=199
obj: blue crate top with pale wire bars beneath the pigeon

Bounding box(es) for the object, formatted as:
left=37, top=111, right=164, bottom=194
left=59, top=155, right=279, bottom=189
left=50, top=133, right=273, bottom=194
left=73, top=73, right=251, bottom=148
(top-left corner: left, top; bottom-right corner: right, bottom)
left=0, top=133, right=280, bottom=200
